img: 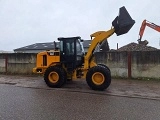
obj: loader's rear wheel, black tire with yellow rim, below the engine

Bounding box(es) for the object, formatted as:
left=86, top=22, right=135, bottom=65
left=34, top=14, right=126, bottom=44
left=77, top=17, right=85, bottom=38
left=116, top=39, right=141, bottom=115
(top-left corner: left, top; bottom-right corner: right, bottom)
left=44, top=66, right=67, bottom=88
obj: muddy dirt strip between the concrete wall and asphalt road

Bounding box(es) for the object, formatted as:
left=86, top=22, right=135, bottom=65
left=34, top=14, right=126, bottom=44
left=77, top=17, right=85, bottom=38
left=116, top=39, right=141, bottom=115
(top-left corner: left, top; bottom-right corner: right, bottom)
left=0, top=75, right=160, bottom=100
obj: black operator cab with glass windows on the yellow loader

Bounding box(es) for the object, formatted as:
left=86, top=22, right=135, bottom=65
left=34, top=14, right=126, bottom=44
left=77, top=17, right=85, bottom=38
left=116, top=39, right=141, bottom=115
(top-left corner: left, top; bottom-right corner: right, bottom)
left=58, top=37, right=84, bottom=71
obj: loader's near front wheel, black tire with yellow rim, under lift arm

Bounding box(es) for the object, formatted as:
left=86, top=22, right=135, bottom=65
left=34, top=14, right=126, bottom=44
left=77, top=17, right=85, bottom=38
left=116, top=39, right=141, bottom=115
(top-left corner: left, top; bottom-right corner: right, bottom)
left=86, top=66, right=111, bottom=91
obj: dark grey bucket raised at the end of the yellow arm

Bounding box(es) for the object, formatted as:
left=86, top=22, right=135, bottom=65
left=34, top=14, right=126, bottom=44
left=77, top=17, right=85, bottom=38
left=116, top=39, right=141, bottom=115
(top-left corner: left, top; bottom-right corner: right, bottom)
left=112, top=6, right=135, bottom=36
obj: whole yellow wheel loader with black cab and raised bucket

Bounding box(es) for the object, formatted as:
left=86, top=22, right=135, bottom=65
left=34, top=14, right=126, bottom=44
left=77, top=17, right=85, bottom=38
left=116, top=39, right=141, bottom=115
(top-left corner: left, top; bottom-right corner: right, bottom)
left=33, top=6, right=135, bottom=90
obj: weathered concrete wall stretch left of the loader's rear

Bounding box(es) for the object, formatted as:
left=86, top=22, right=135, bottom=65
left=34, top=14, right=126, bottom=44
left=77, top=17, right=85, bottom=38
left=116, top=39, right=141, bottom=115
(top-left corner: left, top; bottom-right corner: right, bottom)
left=0, top=53, right=36, bottom=74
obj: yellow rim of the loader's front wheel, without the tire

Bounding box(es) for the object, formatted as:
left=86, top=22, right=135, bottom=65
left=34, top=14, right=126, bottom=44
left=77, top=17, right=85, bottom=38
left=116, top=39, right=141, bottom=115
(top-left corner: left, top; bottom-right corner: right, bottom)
left=92, top=72, right=105, bottom=85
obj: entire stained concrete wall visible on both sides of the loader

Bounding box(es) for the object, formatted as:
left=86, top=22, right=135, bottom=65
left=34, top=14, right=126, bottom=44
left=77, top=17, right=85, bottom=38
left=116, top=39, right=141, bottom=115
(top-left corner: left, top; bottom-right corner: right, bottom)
left=0, top=51, right=160, bottom=79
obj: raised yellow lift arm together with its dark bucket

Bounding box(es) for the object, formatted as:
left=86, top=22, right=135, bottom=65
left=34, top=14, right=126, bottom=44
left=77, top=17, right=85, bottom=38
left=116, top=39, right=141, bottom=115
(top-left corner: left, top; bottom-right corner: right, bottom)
left=84, top=7, right=135, bottom=70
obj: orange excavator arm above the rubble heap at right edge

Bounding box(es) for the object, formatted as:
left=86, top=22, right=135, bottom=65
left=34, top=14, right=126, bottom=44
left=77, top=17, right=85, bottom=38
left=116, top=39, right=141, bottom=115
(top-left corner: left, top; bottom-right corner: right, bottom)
left=138, top=20, right=160, bottom=42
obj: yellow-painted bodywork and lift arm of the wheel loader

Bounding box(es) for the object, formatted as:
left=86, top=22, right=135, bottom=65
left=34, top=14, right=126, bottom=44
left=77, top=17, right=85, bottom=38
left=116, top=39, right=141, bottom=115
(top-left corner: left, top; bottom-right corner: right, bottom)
left=33, top=28, right=115, bottom=81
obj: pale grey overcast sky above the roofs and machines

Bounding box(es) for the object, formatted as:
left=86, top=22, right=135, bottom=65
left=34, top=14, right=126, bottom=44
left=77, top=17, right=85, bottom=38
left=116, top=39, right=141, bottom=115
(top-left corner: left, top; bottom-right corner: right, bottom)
left=0, top=0, right=160, bottom=51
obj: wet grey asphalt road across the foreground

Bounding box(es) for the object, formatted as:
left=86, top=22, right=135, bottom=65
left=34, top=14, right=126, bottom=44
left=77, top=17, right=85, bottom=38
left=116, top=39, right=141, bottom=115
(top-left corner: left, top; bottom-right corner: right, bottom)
left=0, top=84, right=160, bottom=120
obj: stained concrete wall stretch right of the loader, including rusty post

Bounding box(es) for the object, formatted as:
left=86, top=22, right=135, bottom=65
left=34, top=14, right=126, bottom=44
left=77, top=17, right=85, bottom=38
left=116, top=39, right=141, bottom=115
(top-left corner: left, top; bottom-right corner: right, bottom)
left=95, top=51, right=160, bottom=79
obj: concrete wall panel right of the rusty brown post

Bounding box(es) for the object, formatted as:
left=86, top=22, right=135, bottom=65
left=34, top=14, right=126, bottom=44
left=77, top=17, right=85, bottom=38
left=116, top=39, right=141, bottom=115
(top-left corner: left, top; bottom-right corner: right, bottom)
left=132, top=51, right=160, bottom=78
